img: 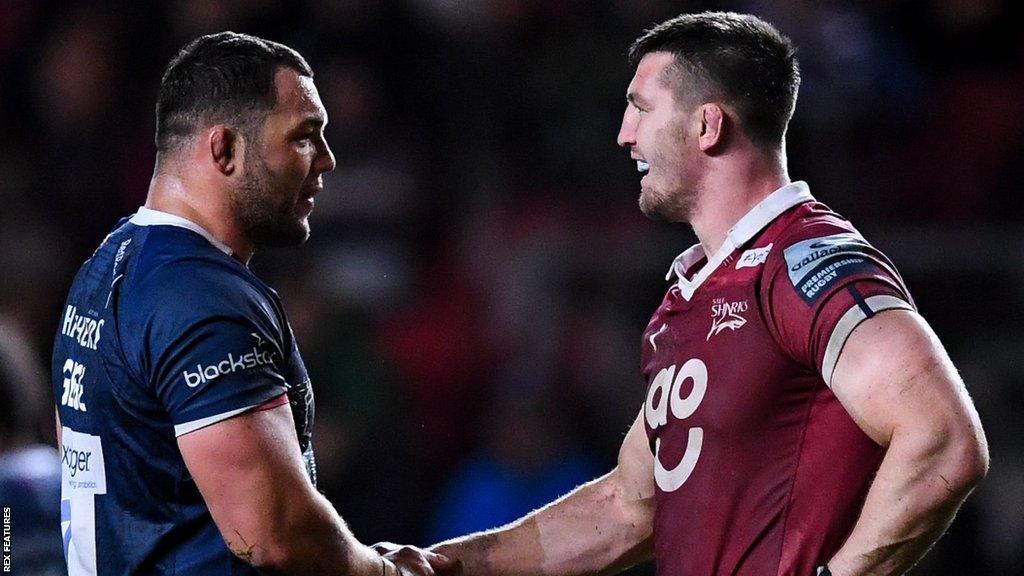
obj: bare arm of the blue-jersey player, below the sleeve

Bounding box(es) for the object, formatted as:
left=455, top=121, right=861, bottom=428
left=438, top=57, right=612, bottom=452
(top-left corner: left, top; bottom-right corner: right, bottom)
left=178, top=404, right=381, bottom=576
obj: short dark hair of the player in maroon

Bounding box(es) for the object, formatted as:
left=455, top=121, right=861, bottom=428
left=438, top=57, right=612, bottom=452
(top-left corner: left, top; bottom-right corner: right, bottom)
left=629, top=12, right=800, bottom=149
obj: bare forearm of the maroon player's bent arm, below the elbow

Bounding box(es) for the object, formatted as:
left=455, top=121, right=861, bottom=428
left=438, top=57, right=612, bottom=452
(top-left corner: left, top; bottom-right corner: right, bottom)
left=828, top=434, right=987, bottom=576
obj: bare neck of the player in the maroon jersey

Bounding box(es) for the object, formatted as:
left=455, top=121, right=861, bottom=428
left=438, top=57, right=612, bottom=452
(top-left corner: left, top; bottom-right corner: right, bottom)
left=690, top=148, right=790, bottom=257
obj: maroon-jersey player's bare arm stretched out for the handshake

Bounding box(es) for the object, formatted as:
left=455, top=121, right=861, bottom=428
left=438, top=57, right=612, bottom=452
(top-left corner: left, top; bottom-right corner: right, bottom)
left=434, top=412, right=654, bottom=576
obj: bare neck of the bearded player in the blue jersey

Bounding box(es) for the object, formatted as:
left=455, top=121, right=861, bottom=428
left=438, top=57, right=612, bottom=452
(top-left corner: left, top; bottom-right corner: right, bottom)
left=145, top=171, right=255, bottom=264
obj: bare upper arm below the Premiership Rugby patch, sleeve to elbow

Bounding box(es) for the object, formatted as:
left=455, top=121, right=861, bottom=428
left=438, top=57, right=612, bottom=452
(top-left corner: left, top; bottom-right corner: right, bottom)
left=831, top=311, right=980, bottom=446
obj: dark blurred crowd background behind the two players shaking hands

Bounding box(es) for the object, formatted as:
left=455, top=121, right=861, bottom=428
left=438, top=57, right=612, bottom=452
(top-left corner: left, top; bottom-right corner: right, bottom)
left=0, top=0, right=1024, bottom=575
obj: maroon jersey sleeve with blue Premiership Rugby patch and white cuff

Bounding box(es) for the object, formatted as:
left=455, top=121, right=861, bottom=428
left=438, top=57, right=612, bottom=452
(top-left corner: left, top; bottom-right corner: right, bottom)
left=761, top=228, right=914, bottom=385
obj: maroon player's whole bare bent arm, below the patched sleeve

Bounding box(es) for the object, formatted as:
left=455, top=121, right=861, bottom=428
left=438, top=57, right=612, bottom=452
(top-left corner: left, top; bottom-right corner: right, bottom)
left=828, top=311, right=988, bottom=576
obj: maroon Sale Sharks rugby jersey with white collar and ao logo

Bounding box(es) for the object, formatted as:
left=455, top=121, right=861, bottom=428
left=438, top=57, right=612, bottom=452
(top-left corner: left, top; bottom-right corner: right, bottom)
left=641, top=182, right=912, bottom=576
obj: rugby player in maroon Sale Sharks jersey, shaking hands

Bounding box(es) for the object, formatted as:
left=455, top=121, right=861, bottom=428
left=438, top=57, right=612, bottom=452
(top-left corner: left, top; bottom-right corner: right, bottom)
left=374, top=8, right=988, bottom=576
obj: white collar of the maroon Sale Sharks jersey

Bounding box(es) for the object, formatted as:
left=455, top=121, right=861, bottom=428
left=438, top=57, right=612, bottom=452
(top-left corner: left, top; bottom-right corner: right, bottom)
left=665, top=181, right=814, bottom=300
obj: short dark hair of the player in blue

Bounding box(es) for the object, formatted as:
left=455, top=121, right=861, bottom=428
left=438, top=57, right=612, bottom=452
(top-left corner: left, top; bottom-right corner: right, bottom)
left=156, top=32, right=313, bottom=154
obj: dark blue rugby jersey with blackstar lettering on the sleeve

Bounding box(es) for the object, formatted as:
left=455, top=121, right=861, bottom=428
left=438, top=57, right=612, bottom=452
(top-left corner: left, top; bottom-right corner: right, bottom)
left=52, top=208, right=316, bottom=576
